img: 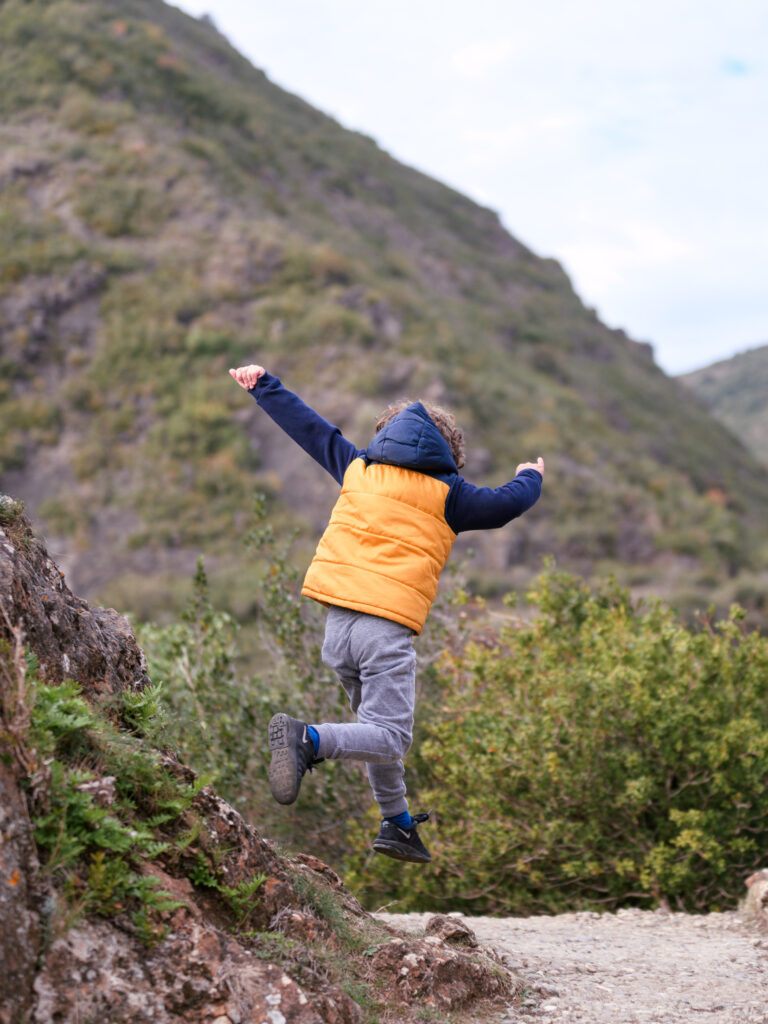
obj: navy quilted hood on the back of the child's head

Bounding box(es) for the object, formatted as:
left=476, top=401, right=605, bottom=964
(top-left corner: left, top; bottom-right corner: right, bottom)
left=366, top=401, right=457, bottom=474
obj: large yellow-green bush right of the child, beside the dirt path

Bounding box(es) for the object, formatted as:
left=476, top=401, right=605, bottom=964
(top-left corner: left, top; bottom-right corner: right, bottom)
left=348, top=568, right=768, bottom=913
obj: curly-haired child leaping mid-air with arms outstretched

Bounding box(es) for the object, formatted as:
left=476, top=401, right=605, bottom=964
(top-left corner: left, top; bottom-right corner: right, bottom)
left=229, top=366, right=544, bottom=863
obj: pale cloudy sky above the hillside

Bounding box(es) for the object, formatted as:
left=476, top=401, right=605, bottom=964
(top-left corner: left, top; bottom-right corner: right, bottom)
left=174, top=0, right=768, bottom=374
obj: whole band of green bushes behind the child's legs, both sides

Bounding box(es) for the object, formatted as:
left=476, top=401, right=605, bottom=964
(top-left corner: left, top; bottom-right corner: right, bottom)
left=129, top=524, right=768, bottom=914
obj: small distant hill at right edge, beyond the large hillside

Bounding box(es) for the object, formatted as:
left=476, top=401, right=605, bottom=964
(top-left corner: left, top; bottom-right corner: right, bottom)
left=680, top=345, right=768, bottom=466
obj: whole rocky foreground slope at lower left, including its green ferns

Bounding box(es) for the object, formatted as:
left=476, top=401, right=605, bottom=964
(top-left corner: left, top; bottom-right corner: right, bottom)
left=0, top=495, right=519, bottom=1024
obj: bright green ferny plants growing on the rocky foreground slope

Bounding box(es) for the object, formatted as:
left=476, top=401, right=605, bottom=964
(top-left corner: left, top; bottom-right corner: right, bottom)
left=24, top=675, right=203, bottom=943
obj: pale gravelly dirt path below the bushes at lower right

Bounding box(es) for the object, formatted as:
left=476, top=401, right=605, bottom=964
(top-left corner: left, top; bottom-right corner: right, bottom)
left=380, top=910, right=768, bottom=1024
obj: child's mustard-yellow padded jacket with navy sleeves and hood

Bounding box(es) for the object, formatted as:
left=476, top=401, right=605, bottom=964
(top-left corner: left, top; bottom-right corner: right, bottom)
left=252, top=374, right=542, bottom=633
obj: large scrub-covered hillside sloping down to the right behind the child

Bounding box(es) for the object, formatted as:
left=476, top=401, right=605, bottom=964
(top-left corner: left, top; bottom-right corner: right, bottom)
left=0, top=0, right=768, bottom=617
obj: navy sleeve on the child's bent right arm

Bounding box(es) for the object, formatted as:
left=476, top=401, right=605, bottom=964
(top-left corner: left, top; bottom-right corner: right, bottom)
left=445, top=469, right=542, bottom=534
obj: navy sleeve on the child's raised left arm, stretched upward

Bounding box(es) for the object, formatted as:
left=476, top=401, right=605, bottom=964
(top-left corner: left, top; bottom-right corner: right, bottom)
left=251, top=374, right=362, bottom=483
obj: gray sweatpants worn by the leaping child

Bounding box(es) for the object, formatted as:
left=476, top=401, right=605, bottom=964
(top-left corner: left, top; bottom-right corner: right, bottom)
left=315, top=606, right=416, bottom=817
